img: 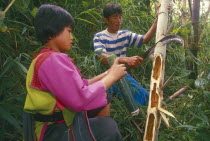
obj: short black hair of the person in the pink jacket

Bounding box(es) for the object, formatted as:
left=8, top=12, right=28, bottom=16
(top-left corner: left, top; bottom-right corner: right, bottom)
left=34, top=4, right=74, bottom=44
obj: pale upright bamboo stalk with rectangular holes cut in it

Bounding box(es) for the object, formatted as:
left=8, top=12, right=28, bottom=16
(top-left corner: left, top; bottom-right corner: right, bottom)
left=144, top=0, right=169, bottom=141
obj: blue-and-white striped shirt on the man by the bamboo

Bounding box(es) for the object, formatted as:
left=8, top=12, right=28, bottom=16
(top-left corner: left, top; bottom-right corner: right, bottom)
left=93, top=29, right=144, bottom=57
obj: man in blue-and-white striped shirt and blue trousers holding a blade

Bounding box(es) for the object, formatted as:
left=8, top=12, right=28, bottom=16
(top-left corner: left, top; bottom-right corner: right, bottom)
left=93, top=3, right=161, bottom=105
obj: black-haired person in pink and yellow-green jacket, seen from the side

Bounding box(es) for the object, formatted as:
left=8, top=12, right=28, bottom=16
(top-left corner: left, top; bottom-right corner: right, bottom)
left=24, top=4, right=126, bottom=141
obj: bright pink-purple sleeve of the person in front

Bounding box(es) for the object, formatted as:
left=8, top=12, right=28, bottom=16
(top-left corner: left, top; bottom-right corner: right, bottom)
left=38, top=53, right=107, bottom=112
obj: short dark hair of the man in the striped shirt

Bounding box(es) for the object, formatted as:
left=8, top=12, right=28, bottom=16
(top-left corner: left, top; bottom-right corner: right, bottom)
left=103, top=3, right=122, bottom=18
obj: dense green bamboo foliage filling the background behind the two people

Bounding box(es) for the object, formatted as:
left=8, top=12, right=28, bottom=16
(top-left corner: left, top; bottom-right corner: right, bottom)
left=0, top=0, right=210, bottom=141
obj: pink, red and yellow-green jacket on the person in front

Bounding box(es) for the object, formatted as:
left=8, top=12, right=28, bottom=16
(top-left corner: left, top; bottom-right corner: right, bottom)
left=24, top=49, right=107, bottom=141
